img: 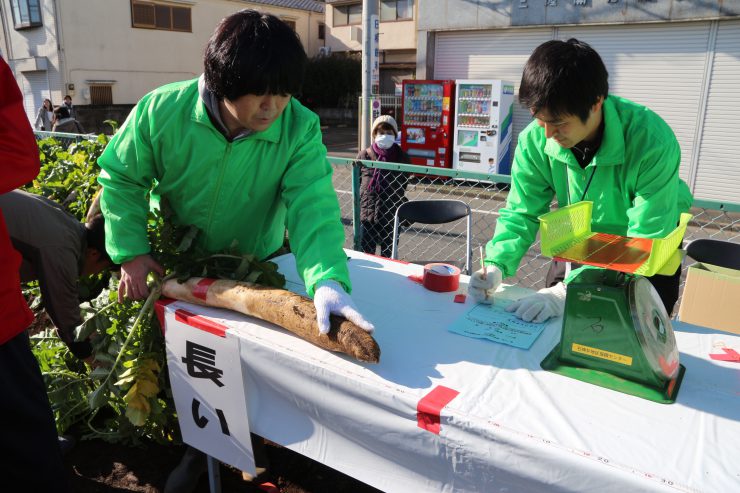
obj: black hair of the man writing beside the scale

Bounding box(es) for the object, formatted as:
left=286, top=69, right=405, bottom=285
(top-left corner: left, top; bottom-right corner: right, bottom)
left=519, top=38, right=609, bottom=123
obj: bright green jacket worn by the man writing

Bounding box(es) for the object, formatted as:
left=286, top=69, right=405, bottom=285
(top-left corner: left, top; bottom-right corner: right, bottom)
left=486, top=95, right=693, bottom=277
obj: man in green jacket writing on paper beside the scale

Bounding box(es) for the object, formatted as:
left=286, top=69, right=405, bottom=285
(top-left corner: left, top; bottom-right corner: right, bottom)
left=469, top=39, right=693, bottom=322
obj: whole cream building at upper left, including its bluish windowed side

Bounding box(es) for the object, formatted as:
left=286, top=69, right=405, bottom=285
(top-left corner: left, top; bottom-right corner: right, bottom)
left=0, top=0, right=324, bottom=127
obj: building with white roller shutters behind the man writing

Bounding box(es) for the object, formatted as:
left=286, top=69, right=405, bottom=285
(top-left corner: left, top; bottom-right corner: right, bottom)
left=416, top=0, right=740, bottom=203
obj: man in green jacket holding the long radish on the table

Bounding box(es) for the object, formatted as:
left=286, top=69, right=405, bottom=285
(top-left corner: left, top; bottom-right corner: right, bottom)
left=99, top=10, right=373, bottom=333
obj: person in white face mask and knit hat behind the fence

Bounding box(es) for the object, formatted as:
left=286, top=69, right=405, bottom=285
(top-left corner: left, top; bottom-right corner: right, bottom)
left=357, top=115, right=411, bottom=257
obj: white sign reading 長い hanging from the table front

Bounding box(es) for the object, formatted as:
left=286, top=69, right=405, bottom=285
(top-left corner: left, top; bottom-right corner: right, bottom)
left=165, top=305, right=255, bottom=475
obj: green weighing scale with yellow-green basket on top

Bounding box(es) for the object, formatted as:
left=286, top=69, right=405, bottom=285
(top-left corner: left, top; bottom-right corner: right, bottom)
left=540, top=202, right=691, bottom=404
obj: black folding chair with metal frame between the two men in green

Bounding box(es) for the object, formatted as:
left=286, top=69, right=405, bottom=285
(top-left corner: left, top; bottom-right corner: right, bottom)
left=391, top=200, right=472, bottom=274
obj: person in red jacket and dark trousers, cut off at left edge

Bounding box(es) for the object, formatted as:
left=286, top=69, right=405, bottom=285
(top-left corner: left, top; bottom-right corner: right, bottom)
left=0, top=58, right=69, bottom=492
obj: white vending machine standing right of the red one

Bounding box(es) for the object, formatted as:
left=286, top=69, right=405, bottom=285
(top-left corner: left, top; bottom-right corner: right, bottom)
left=452, top=80, right=514, bottom=175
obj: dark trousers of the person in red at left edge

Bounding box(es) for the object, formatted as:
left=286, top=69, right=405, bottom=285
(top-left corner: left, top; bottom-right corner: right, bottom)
left=0, top=331, right=71, bottom=493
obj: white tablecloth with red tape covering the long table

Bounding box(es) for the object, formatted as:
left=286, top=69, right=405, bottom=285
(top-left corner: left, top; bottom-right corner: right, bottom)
left=167, top=251, right=740, bottom=493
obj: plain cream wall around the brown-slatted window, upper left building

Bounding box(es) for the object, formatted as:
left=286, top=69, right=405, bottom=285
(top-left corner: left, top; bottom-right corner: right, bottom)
left=60, top=0, right=323, bottom=104
